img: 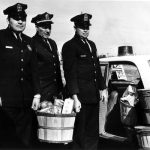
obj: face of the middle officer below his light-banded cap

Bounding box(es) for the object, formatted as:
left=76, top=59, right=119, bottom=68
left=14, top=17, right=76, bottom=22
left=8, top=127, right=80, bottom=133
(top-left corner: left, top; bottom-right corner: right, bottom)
left=37, top=26, right=51, bottom=38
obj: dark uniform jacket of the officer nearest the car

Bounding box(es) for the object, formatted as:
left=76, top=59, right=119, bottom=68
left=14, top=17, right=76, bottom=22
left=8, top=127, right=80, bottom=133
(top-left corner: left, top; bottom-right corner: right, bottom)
left=62, top=34, right=105, bottom=103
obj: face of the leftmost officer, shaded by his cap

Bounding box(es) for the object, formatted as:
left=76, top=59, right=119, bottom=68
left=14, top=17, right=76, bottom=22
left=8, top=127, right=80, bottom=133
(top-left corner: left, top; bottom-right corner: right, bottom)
left=8, top=18, right=26, bottom=32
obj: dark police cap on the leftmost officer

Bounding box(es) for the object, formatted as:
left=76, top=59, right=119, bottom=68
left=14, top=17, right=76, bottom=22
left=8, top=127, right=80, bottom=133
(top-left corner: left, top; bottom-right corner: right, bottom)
left=3, top=3, right=27, bottom=20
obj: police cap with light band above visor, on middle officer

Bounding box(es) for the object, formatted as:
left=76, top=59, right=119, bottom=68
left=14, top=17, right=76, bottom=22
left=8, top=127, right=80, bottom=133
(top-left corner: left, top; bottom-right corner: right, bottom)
left=31, top=12, right=53, bottom=27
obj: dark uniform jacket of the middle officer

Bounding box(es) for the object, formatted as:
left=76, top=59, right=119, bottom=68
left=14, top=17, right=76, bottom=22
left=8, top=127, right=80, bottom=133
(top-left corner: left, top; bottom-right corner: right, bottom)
left=32, top=34, right=63, bottom=101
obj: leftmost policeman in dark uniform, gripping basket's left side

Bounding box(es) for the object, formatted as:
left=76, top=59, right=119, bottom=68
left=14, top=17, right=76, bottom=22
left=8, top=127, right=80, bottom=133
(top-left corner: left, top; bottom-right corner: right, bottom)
left=0, top=3, right=40, bottom=147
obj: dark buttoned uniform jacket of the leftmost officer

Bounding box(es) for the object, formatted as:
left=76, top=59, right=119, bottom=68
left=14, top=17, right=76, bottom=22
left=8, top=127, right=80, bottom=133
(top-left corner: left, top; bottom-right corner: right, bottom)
left=0, top=28, right=40, bottom=107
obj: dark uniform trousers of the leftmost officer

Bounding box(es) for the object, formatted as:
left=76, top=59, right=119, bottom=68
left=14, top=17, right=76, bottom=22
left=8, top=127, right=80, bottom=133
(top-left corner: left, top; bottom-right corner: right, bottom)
left=0, top=107, right=37, bottom=148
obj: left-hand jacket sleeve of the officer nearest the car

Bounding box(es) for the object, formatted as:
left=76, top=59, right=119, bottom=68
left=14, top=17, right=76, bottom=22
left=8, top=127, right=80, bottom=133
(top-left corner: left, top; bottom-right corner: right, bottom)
left=62, top=43, right=79, bottom=95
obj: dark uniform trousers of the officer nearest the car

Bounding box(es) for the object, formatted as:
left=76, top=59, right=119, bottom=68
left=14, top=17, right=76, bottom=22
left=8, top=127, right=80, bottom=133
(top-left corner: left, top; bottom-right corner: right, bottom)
left=73, top=104, right=99, bottom=150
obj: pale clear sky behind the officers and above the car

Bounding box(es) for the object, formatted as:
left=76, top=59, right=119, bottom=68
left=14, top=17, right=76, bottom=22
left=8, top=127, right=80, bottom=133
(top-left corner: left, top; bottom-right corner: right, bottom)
left=0, top=0, right=150, bottom=55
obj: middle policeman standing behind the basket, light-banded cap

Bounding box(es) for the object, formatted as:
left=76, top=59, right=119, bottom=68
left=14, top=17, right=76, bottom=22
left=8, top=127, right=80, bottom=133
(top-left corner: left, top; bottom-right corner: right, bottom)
left=31, top=12, right=63, bottom=102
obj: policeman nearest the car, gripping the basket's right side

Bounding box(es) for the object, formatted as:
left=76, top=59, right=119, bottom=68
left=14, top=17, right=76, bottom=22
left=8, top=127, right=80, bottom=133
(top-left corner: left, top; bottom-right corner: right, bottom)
left=62, top=13, right=107, bottom=150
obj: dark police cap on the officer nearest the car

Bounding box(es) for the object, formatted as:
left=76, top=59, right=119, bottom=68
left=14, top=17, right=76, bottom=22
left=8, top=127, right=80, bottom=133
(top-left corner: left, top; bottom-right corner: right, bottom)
left=70, top=13, right=92, bottom=29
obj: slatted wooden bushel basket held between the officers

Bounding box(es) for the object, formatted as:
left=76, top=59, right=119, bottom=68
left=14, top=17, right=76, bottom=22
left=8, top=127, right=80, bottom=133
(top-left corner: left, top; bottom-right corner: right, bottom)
left=37, top=112, right=75, bottom=143
